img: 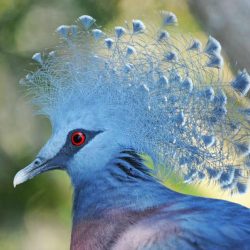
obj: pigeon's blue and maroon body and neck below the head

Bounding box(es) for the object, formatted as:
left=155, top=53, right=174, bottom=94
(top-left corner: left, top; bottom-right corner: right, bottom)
left=71, top=150, right=250, bottom=250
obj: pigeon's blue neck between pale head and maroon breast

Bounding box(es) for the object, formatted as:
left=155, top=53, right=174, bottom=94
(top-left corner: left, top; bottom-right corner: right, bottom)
left=73, top=150, right=178, bottom=224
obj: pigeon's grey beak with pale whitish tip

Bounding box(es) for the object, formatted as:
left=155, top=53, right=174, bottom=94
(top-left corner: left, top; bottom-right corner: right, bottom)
left=13, top=157, right=58, bottom=187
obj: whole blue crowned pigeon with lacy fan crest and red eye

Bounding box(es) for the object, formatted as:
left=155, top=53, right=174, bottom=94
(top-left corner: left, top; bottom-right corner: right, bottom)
left=14, top=11, right=250, bottom=250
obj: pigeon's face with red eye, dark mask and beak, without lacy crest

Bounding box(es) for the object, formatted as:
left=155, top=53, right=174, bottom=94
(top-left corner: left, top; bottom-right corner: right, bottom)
left=14, top=106, right=132, bottom=186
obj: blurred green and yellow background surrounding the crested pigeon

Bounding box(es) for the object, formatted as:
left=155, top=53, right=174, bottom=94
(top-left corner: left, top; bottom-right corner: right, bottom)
left=0, top=0, right=250, bottom=250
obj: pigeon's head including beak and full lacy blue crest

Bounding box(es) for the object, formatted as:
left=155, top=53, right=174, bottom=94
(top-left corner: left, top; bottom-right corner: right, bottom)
left=14, top=12, right=250, bottom=192
